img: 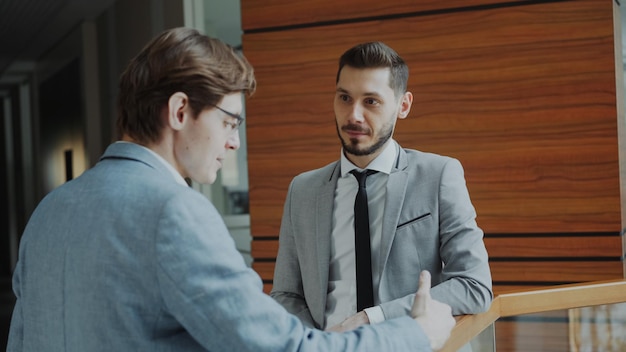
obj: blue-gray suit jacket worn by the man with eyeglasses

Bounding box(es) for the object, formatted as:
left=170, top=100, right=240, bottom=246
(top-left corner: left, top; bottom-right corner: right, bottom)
left=7, top=143, right=430, bottom=352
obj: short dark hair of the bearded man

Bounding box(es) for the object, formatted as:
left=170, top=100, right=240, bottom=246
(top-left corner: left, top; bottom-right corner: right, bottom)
left=336, top=42, right=409, bottom=96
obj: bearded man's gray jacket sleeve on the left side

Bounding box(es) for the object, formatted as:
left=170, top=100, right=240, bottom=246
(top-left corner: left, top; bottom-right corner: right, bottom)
left=270, top=181, right=321, bottom=329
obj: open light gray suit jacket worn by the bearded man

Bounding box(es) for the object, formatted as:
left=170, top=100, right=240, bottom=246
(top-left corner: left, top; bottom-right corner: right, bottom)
left=271, top=149, right=493, bottom=328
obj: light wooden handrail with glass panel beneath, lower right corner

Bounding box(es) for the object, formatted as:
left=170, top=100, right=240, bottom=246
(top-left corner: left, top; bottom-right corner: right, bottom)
left=441, top=279, right=626, bottom=352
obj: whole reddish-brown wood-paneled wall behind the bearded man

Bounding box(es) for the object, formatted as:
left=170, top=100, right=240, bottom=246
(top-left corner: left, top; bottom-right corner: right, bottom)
left=242, top=0, right=624, bottom=291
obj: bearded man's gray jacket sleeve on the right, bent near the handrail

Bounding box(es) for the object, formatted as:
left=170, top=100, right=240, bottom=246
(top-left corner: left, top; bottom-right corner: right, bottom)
left=381, top=158, right=493, bottom=319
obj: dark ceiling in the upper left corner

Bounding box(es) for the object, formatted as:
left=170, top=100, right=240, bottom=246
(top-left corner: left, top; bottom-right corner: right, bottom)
left=0, top=0, right=115, bottom=85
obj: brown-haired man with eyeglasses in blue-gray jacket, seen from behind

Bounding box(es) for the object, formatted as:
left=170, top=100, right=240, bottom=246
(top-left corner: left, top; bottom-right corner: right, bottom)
left=7, top=28, right=454, bottom=352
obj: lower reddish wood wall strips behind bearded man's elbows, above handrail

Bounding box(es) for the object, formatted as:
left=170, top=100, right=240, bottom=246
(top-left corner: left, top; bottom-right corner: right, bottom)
left=252, top=234, right=622, bottom=292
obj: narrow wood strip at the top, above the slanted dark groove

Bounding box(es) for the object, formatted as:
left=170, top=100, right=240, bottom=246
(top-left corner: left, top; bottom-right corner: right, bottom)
left=241, top=0, right=523, bottom=31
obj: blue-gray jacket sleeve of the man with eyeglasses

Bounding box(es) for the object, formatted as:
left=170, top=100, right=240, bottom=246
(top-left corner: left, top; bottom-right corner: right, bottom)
left=155, top=190, right=430, bottom=352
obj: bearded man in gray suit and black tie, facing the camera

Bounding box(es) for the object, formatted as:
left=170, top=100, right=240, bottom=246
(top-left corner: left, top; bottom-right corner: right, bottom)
left=271, top=42, right=493, bottom=331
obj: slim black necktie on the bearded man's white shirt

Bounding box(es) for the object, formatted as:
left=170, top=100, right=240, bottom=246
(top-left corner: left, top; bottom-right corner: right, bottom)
left=351, top=170, right=376, bottom=312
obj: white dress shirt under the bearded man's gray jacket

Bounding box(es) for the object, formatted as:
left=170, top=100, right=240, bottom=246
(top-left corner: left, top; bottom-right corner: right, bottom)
left=325, top=140, right=399, bottom=327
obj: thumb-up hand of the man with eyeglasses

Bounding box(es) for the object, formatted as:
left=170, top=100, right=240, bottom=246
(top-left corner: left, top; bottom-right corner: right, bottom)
left=411, top=270, right=456, bottom=350
